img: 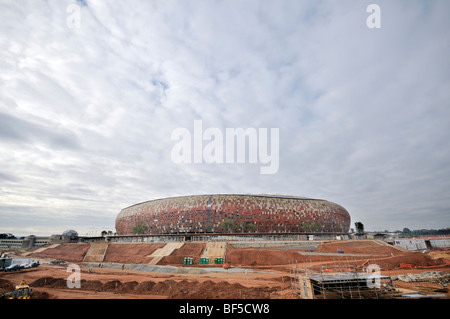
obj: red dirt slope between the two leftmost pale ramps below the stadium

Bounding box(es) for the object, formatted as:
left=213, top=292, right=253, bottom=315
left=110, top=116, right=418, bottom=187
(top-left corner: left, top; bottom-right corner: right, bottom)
left=103, top=243, right=165, bottom=264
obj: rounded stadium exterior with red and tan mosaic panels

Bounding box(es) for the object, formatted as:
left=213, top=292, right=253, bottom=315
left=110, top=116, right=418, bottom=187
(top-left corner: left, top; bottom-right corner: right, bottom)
left=116, top=195, right=350, bottom=235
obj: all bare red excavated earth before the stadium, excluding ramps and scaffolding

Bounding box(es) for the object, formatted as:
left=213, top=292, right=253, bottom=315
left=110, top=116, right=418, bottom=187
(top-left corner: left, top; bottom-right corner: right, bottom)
left=0, top=240, right=450, bottom=299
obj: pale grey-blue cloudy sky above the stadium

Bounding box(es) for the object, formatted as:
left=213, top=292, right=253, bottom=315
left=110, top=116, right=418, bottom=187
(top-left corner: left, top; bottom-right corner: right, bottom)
left=0, top=0, right=450, bottom=235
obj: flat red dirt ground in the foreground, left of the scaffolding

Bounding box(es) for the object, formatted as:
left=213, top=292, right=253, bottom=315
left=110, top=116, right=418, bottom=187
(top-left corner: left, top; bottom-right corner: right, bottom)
left=0, top=265, right=290, bottom=299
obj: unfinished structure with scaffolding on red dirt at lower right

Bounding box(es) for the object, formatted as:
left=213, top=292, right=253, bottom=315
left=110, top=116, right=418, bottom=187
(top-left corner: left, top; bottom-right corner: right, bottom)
left=289, top=260, right=390, bottom=299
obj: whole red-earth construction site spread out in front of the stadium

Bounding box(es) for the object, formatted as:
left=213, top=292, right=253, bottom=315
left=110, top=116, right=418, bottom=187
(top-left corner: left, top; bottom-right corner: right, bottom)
left=0, top=237, right=450, bottom=299
